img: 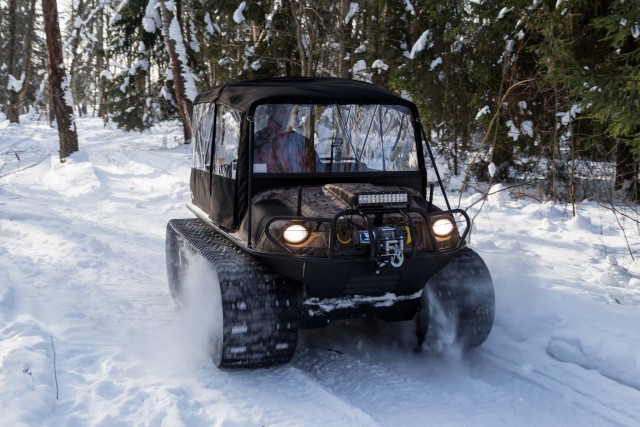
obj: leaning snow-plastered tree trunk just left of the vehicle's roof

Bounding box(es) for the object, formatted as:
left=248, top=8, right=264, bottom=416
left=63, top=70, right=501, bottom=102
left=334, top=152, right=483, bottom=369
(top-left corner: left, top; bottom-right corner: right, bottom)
left=158, top=0, right=192, bottom=144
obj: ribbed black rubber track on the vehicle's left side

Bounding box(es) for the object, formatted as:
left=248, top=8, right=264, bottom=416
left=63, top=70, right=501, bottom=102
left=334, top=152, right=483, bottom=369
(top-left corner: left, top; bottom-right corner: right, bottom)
left=166, top=218, right=301, bottom=368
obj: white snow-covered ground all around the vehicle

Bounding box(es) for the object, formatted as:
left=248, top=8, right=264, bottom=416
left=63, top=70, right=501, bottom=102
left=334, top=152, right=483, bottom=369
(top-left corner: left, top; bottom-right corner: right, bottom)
left=0, top=117, right=640, bottom=426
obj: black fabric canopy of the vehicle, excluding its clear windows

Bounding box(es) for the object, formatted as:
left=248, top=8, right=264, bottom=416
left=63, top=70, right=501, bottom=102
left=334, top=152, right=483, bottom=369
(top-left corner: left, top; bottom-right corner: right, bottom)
left=191, top=77, right=426, bottom=230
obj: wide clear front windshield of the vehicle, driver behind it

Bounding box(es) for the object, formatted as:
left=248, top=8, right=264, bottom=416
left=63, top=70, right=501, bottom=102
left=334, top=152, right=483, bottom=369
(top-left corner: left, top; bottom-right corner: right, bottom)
left=253, top=104, right=418, bottom=173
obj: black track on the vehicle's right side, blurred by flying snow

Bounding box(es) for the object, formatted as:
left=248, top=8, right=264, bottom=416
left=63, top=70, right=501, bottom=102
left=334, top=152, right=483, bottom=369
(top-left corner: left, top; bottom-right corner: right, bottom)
left=416, top=248, right=495, bottom=351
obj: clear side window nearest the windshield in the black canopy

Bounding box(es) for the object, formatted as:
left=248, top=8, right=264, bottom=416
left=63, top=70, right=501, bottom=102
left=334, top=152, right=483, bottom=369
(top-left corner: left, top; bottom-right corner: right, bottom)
left=213, top=105, right=241, bottom=178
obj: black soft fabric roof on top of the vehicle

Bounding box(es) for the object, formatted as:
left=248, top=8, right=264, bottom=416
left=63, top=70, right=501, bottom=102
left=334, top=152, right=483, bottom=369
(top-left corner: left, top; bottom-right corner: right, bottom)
left=194, top=77, right=417, bottom=113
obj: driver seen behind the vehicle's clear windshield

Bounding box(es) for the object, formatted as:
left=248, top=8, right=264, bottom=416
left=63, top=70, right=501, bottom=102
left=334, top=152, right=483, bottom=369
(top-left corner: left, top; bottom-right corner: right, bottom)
left=253, top=104, right=314, bottom=173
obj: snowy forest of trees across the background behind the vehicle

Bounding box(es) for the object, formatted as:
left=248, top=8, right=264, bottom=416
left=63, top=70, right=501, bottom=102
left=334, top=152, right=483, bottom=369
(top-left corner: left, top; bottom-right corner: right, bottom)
left=0, top=0, right=640, bottom=202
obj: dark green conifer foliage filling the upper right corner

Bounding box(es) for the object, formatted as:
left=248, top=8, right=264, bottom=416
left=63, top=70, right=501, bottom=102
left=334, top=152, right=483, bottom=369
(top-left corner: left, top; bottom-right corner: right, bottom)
left=540, top=0, right=640, bottom=199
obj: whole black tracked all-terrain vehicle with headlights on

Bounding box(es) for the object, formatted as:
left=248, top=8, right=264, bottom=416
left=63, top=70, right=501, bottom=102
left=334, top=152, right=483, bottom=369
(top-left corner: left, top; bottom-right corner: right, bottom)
left=166, top=78, right=495, bottom=368
